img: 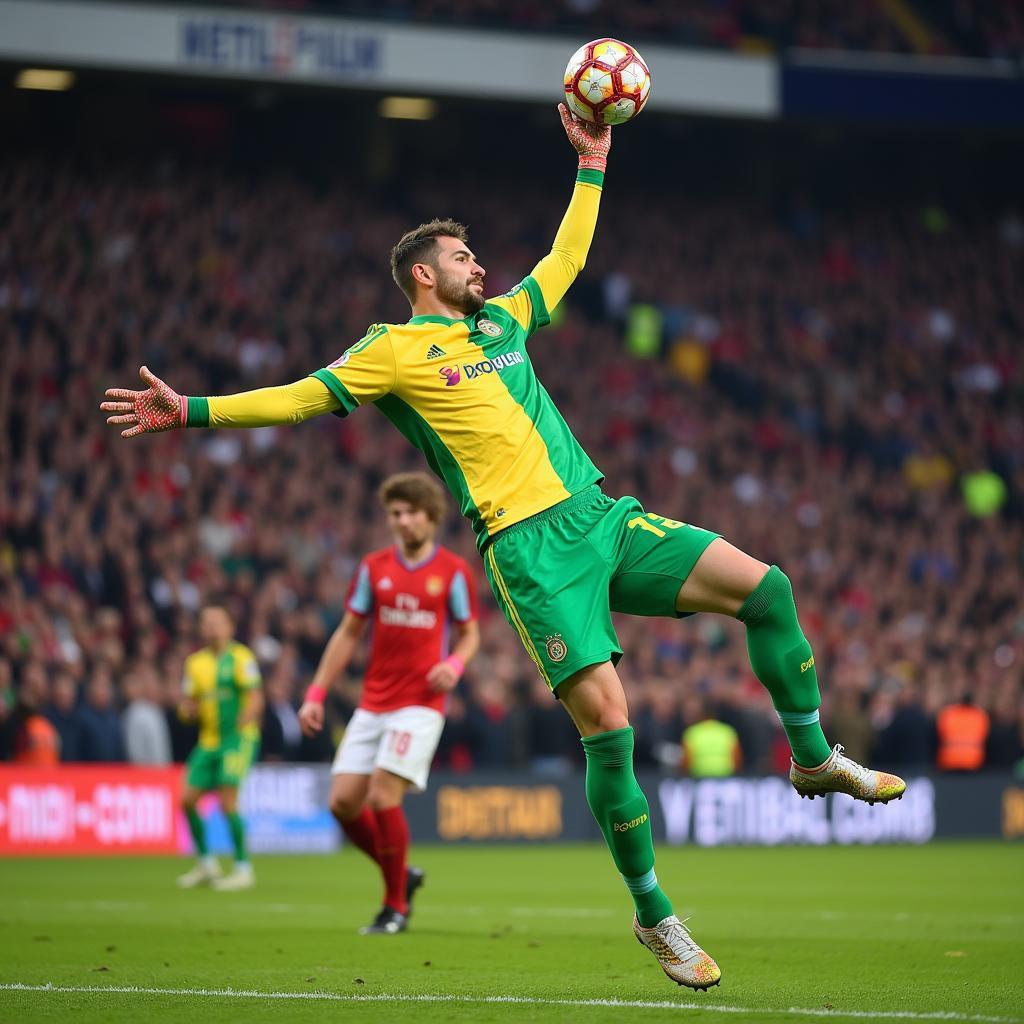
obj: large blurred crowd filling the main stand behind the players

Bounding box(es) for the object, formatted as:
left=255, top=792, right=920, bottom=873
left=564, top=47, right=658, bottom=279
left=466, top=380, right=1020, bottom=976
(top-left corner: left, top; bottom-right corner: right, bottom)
left=0, top=151, right=1024, bottom=771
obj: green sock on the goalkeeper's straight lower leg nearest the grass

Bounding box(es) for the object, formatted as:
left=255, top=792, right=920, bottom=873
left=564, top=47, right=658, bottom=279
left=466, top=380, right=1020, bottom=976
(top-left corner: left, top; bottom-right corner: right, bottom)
left=583, top=726, right=672, bottom=928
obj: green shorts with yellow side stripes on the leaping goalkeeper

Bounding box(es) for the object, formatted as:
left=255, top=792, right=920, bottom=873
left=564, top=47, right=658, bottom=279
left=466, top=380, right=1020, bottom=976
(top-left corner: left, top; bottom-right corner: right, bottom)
left=483, top=485, right=719, bottom=690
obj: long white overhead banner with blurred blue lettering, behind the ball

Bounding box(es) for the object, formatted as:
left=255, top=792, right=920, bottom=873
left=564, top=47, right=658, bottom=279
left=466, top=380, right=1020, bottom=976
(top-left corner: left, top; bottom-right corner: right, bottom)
left=0, top=0, right=779, bottom=118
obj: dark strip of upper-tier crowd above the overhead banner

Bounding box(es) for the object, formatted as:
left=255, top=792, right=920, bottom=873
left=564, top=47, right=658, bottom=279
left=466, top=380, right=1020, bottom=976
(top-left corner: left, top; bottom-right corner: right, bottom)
left=188, top=0, right=1024, bottom=66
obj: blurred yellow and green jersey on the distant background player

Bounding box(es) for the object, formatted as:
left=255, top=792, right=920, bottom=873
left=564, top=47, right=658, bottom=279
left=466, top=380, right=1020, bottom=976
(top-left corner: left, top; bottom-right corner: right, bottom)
left=182, top=641, right=260, bottom=751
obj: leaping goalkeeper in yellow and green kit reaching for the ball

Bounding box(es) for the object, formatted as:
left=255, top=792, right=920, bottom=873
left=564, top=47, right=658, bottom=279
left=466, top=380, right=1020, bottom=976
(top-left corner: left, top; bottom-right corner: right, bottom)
left=101, top=106, right=905, bottom=988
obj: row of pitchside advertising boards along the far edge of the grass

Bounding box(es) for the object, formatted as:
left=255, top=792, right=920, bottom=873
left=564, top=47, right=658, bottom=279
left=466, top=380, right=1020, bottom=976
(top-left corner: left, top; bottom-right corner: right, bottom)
left=0, top=764, right=1024, bottom=856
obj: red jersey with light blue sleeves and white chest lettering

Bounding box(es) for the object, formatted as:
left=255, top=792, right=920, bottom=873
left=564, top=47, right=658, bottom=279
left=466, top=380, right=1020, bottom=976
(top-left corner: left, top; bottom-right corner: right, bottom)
left=345, top=545, right=476, bottom=713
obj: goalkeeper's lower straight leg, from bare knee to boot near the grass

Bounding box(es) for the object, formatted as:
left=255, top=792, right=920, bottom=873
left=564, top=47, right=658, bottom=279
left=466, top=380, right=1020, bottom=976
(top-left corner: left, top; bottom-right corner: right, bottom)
left=557, top=662, right=721, bottom=988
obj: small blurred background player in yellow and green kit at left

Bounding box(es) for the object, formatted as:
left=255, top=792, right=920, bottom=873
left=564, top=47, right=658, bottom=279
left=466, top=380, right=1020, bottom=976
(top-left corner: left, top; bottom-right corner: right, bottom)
left=178, top=604, right=263, bottom=891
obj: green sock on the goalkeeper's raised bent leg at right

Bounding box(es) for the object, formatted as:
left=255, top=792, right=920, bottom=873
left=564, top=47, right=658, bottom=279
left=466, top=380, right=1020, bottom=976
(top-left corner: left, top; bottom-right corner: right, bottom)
left=736, top=565, right=831, bottom=768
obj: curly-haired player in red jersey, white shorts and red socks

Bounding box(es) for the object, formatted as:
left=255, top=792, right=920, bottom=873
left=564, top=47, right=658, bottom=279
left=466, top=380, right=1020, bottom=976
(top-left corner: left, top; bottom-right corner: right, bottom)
left=299, top=473, right=480, bottom=935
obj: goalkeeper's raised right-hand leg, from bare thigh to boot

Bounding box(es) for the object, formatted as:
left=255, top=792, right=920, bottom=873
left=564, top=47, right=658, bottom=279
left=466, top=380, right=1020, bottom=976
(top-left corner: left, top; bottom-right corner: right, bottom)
left=676, top=538, right=906, bottom=803
